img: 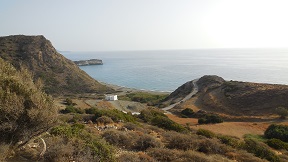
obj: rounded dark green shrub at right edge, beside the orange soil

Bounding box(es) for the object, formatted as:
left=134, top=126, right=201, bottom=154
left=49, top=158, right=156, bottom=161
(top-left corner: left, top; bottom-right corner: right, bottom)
left=264, top=124, right=288, bottom=142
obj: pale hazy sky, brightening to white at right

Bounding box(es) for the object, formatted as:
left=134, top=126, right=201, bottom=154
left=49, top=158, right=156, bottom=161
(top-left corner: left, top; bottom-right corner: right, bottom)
left=0, top=0, right=288, bottom=51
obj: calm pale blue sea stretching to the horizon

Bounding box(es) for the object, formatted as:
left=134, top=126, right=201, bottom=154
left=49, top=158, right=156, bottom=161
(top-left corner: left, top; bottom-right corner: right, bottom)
left=60, top=49, right=288, bottom=92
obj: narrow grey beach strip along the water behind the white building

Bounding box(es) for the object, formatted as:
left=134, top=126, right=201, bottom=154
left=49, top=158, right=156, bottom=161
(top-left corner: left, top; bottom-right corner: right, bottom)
left=98, top=81, right=172, bottom=95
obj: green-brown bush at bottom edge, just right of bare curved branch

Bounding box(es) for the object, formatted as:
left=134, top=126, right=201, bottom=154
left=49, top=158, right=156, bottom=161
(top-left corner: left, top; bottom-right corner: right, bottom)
left=48, top=124, right=115, bottom=162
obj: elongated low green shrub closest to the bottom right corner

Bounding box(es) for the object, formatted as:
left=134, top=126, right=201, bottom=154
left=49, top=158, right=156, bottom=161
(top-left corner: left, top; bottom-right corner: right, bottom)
left=243, top=139, right=280, bottom=162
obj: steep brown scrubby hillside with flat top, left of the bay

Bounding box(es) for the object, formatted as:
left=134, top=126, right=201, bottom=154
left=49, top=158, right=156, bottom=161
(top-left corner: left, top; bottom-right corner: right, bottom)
left=0, top=35, right=112, bottom=95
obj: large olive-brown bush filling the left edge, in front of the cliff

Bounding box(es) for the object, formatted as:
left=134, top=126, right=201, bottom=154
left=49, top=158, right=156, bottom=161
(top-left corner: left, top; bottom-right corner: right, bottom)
left=0, top=59, right=57, bottom=146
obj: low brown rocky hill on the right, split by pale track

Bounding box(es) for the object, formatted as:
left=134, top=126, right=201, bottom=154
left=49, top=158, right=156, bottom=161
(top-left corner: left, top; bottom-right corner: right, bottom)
left=168, top=76, right=288, bottom=116
